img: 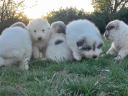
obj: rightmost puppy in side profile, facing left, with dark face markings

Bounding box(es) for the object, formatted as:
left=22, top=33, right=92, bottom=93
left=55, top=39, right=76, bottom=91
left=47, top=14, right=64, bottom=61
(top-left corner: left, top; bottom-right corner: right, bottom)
left=104, top=20, right=128, bottom=60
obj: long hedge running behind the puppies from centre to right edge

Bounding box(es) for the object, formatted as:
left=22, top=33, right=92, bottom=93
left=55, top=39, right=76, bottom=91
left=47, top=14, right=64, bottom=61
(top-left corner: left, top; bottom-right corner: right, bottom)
left=46, top=8, right=128, bottom=34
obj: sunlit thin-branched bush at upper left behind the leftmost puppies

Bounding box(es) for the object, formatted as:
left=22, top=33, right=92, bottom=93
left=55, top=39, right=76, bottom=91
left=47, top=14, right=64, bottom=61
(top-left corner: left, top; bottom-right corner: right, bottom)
left=0, top=0, right=28, bottom=33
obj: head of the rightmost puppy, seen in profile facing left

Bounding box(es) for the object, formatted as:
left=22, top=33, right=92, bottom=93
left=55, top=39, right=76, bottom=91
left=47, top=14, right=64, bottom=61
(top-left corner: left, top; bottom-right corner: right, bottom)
left=104, top=20, right=126, bottom=40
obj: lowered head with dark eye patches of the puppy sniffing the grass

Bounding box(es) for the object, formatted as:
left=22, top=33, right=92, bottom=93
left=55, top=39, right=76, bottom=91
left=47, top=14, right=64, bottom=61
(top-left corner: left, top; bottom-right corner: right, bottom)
left=76, top=38, right=103, bottom=58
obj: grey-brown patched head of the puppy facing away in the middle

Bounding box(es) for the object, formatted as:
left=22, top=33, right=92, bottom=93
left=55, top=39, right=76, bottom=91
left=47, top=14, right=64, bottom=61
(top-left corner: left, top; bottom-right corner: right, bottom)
left=51, top=21, right=66, bottom=34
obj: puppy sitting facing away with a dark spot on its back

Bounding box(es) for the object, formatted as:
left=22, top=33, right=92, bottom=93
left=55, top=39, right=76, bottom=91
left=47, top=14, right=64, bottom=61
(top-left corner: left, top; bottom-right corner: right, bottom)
left=46, top=21, right=72, bottom=62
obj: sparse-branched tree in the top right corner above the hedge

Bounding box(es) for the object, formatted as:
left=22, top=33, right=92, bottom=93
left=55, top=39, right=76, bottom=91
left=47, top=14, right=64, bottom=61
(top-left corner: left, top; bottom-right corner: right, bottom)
left=92, top=0, right=128, bottom=13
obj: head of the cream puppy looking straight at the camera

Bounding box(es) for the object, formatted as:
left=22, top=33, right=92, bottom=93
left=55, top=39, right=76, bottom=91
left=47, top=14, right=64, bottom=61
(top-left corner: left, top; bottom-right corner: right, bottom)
left=27, top=19, right=50, bottom=41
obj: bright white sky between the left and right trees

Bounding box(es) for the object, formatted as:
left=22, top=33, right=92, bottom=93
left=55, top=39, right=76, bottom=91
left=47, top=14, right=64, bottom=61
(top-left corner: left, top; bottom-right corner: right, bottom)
left=24, top=0, right=94, bottom=19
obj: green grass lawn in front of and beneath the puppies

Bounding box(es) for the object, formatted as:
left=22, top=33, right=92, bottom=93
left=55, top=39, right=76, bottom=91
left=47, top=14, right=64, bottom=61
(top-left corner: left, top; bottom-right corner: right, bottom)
left=0, top=43, right=128, bottom=96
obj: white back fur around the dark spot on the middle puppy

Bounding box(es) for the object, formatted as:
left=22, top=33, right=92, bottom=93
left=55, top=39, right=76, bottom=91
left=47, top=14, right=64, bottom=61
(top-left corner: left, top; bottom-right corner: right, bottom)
left=46, top=34, right=72, bottom=62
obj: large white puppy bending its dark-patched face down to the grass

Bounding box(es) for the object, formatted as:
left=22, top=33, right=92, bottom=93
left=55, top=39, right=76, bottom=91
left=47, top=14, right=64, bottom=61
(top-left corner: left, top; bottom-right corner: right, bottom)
left=66, top=19, right=103, bottom=60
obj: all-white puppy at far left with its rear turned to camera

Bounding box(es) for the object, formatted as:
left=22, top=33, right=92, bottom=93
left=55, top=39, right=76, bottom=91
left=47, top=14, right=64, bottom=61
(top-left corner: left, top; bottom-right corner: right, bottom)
left=0, top=26, right=32, bottom=70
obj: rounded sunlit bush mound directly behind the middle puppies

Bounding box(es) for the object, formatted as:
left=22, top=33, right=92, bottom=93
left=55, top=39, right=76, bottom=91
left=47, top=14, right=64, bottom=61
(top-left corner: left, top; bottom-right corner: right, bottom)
left=46, top=8, right=86, bottom=24
